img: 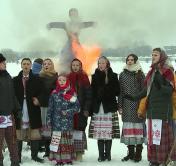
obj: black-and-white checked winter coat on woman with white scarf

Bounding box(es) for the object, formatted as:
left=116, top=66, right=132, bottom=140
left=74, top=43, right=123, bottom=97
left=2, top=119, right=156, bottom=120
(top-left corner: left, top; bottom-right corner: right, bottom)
left=119, top=69, right=145, bottom=123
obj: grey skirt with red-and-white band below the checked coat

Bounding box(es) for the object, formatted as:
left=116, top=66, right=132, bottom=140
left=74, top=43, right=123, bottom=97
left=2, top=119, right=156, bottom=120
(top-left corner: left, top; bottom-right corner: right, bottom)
left=120, top=122, right=147, bottom=145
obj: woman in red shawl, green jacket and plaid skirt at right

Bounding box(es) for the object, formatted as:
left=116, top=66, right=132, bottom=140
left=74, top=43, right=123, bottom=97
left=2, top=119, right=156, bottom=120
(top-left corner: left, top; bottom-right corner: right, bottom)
left=126, top=48, right=176, bottom=166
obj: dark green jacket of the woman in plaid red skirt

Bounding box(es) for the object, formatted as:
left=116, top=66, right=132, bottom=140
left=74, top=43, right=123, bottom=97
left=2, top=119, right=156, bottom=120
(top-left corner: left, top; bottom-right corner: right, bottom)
left=147, top=72, right=173, bottom=121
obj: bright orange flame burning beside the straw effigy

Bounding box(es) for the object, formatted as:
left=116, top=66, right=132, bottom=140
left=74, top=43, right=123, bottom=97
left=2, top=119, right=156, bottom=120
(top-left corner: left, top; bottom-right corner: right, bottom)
left=72, top=38, right=101, bottom=75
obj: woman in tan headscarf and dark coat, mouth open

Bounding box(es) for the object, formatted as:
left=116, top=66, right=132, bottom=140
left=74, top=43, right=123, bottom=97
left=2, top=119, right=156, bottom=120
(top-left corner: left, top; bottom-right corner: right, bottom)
left=38, top=58, right=58, bottom=157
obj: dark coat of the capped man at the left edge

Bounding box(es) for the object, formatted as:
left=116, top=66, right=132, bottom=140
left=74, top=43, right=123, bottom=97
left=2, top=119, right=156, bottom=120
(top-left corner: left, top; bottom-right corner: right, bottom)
left=0, top=70, right=20, bottom=116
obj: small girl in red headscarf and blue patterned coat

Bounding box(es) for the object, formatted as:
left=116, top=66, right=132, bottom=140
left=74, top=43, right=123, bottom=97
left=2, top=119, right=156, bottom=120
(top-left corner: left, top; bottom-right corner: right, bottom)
left=47, top=74, right=79, bottom=165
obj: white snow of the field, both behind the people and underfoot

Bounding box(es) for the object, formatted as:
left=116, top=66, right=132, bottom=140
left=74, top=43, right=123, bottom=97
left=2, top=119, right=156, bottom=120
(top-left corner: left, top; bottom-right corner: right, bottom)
left=4, top=61, right=176, bottom=166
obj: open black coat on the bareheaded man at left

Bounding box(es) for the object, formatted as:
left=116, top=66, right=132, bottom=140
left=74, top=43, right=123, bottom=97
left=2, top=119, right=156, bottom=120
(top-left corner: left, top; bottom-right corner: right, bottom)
left=13, top=71, right=42, bottom=129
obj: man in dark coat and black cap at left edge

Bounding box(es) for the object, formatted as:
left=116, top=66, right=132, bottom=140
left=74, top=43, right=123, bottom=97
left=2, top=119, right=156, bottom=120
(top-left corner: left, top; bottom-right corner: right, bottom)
left=0, top=54, right=19, bottom=166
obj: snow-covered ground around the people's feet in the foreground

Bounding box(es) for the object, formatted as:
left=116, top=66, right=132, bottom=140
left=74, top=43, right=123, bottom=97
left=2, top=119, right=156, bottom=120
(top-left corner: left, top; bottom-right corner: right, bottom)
left=4, top=118, right=148, bottom=166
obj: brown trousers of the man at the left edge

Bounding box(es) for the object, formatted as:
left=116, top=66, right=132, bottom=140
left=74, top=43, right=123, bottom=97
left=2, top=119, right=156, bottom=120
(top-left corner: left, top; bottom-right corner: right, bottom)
left=0, top=126, right=19, bottom=161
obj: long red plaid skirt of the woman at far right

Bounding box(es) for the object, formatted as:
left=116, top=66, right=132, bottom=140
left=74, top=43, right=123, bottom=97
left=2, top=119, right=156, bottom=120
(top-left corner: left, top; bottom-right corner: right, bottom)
left=148, top=121, right=176, bottom=164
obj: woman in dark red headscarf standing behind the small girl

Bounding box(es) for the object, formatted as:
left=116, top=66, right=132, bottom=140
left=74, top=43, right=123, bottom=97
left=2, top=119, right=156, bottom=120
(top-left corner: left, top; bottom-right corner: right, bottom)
left=68, top=59, right=91, bottom=161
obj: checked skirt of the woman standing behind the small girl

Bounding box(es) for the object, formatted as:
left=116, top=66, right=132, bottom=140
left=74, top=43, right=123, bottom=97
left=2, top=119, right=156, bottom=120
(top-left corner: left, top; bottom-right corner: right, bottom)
left=73, top=130, right=87, bottom=153
